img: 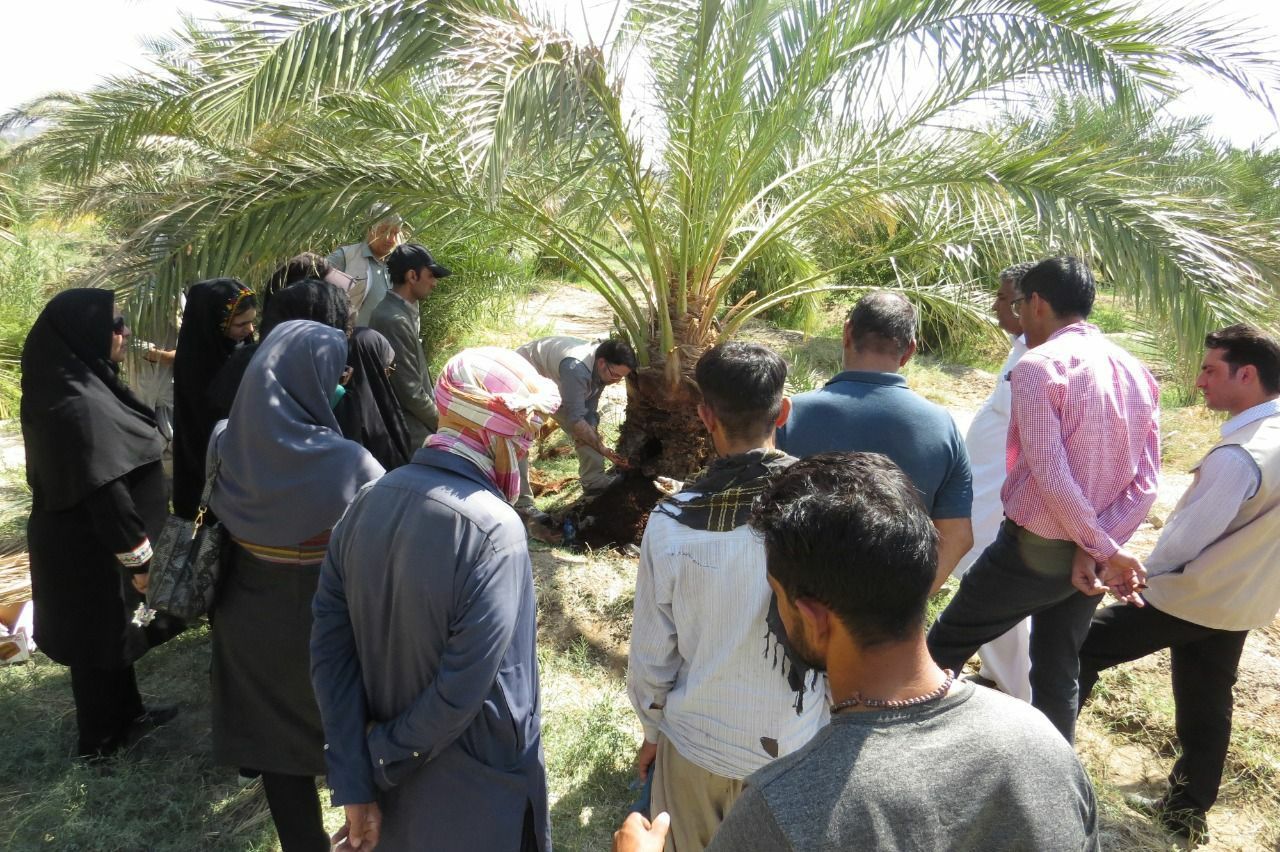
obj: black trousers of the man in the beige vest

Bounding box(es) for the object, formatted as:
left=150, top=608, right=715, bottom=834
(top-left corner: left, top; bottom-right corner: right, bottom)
left=1080, top=604, right=1249, bottom=814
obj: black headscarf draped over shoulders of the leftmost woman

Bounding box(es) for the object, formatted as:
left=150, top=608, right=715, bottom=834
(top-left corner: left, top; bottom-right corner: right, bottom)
left=20, top=289, right=164, bottom=510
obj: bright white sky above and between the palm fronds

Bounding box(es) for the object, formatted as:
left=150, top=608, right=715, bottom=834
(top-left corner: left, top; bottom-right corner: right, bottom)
left=0, top=0, right=1280, bottom=147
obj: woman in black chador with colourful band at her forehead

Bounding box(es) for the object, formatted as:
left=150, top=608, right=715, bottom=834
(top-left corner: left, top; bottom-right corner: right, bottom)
left=173, top=278, right=257, bottom=521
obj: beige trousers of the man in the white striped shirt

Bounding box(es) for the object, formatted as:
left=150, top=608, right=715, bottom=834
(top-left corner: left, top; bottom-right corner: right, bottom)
left=649, top=734, right=742, bottom=852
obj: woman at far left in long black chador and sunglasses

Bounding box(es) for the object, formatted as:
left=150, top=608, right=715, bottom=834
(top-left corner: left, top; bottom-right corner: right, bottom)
left=22, top=289, right=175, bottom=757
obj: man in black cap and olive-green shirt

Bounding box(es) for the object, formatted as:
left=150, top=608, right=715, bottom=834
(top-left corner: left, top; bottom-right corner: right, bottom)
left=369, top=243, right=449, bottom=449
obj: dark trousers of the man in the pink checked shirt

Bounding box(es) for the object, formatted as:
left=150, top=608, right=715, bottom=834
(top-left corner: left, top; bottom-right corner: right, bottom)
left=928, top=519, right=1100, bottom=742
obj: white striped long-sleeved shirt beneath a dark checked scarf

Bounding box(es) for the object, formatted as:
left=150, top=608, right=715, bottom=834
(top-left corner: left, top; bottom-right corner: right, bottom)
left=627, top=495, right=828, bottom=779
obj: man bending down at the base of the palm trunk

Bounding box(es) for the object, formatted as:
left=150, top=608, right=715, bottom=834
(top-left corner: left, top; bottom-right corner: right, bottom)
left=516, top=336, right=640, bottom=517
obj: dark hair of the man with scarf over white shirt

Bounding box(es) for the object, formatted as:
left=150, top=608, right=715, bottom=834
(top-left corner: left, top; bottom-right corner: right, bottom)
left=694, top=342, right=787, bottom=439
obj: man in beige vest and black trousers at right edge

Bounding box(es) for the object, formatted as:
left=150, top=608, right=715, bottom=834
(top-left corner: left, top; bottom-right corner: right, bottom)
left=1076, top=325, right=1280, bottom=840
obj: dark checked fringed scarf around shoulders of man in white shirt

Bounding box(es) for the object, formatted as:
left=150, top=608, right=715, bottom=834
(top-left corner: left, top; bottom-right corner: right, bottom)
left=657, top=449, right=818, bottom=714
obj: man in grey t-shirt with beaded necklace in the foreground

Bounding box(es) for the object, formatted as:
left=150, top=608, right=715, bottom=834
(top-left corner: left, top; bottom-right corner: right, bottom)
left=614, top=453, right=1101, bottom=852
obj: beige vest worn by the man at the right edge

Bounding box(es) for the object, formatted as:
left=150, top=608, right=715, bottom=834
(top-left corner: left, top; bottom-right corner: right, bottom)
left=1144, top=414, right=1280, bottom=631
